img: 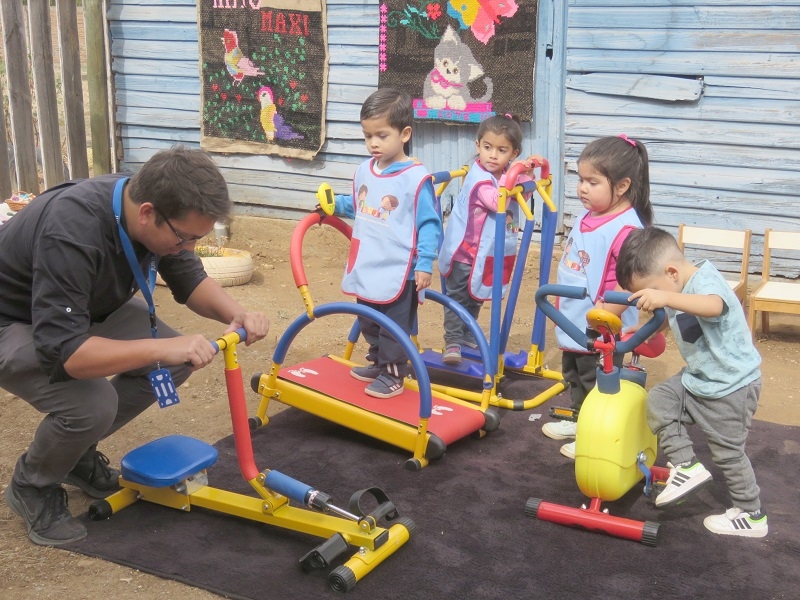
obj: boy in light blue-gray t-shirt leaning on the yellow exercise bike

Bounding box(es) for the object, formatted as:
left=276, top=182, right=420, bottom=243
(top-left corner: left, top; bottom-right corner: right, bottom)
left=617, top=227, right=768, bottom=537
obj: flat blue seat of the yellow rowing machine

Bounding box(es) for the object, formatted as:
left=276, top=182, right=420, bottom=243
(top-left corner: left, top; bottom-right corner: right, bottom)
left=120, top=435, right=217, bottom=488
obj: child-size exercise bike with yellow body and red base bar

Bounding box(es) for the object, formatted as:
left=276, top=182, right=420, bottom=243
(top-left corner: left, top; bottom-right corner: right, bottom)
left=525, top=284, right=669, bottom=546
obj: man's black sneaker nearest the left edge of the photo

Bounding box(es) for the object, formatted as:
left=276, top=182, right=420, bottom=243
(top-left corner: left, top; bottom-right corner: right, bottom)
left=6, top=481, right=86, bottom=546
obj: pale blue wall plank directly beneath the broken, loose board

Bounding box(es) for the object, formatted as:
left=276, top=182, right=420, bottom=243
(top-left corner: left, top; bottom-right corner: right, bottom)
left=566, top=90, right=800, bottom=125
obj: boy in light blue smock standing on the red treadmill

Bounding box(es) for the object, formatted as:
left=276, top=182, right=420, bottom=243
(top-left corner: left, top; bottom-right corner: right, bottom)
left=324, top=88, right=442, bottom=398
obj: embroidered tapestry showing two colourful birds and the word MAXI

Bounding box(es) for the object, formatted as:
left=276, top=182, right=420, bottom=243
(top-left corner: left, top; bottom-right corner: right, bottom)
left=198, top=0, right=328, bottom=159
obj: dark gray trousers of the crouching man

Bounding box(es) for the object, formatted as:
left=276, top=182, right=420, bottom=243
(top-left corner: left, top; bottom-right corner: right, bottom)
left=0, top=298, right=192, bottom=487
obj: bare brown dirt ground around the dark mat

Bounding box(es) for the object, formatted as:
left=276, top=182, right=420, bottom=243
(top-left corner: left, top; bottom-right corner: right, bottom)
left=0, top=216, right=800, bottom=600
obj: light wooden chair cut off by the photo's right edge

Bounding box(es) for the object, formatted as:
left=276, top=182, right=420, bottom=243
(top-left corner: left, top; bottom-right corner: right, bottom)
left=747, top=229, right=800, bottom=336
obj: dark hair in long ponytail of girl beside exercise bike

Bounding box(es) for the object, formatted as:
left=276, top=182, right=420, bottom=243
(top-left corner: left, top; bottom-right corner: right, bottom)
left=578, top=136, right=653, bottom=227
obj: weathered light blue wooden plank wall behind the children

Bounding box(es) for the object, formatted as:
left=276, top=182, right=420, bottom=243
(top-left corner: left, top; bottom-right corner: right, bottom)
left=108, top=0, right=800, bottom=277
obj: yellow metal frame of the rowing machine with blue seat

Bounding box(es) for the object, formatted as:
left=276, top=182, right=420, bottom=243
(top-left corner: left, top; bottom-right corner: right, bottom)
left=100, top=332, right=411, bottom=591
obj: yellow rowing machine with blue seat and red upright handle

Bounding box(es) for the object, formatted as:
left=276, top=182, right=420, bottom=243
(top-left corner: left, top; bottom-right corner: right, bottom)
left=89, top=329, right=415, bottom=592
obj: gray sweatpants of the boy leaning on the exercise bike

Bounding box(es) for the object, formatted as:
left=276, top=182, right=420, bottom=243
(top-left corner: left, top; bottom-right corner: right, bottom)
left=647, top=371, right=761, bottom=512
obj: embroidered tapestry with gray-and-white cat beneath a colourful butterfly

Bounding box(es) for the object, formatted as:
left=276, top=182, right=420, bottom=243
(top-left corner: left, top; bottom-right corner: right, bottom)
left=378, top=0, right=538, bottom=123
